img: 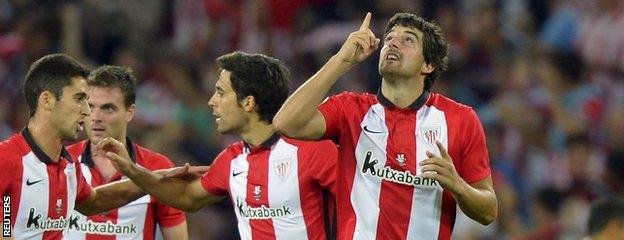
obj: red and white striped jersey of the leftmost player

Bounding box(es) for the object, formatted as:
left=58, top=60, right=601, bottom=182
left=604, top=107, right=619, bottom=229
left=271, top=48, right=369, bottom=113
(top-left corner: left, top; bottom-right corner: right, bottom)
left=0, top=128, right=91, bottom=240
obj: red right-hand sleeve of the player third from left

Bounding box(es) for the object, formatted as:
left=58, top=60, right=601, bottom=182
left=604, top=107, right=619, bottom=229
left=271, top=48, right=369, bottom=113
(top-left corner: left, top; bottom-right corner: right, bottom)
left=310, top=140, right=338, bottom=196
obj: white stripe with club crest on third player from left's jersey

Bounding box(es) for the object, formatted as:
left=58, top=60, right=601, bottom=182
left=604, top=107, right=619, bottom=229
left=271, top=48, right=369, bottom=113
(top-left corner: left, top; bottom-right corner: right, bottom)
left=268, top=139, right=308, bottom=239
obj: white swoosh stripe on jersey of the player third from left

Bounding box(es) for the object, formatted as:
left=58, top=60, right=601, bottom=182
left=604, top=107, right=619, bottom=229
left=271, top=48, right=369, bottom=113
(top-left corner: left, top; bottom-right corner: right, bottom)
left=228, top=153, right=251, bottom=240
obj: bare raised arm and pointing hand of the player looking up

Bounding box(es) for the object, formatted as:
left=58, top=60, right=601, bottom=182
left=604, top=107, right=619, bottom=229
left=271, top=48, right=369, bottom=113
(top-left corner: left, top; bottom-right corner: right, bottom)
left=273, top=13, right=380, bottom=140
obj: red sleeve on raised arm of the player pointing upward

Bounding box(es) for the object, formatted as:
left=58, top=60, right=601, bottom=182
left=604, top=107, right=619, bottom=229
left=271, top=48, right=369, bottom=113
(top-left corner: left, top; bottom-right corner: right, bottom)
left=318, top=92, right=349, bottom=140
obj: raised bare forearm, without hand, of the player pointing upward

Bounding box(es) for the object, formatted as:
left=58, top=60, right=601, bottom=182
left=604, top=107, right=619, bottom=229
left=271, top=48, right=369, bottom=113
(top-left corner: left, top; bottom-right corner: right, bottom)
left=273, top=56, right=351, bottom=137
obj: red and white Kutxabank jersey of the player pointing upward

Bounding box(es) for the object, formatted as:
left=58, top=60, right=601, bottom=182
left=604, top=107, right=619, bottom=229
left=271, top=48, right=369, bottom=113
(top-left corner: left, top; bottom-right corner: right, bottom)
left=319, top=91, right=490, bottom=239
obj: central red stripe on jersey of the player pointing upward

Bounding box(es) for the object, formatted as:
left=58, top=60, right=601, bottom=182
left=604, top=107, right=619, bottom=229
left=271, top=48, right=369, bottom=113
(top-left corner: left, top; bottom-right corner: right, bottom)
left=376, top=109, right=416, bottom=239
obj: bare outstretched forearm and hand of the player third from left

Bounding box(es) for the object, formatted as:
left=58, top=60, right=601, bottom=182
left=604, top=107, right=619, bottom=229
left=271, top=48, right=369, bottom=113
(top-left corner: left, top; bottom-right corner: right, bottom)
left=96, top=138, right=222, bottom=212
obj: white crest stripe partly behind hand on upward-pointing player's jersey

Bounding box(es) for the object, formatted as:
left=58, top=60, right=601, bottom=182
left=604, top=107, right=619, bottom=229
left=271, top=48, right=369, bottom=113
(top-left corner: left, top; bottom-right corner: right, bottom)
left=407, top=106, right=448, bottom=239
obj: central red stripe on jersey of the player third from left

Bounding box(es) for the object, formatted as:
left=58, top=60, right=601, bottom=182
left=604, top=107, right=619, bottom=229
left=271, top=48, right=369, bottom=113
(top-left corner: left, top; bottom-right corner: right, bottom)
left=246, top=151, right=275, bottom=239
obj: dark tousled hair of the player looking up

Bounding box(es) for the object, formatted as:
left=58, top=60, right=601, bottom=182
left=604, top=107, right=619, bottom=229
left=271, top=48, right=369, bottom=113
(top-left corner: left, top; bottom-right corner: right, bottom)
left=384, top=13, right=449, bottom=90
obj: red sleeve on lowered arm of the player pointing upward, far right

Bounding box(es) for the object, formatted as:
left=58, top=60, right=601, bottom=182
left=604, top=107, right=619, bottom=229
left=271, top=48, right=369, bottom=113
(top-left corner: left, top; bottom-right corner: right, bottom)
left=458, top=109, right=491, bottom=183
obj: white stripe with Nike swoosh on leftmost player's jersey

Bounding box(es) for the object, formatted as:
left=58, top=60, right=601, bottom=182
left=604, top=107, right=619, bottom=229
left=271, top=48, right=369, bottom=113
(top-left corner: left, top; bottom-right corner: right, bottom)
left=14, top=152, right=50, bottom=239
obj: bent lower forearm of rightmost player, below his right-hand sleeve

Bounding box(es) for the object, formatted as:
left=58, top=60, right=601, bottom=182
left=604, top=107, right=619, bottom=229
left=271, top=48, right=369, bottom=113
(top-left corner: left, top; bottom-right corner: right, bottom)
left=453, top=182, right=498, bottom=225
